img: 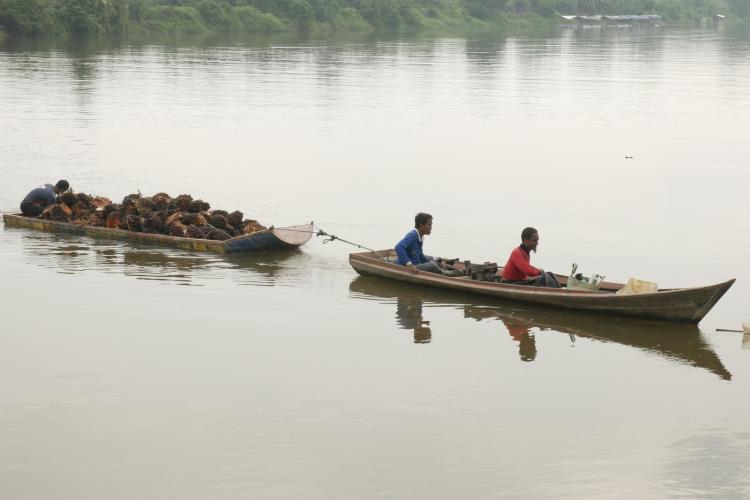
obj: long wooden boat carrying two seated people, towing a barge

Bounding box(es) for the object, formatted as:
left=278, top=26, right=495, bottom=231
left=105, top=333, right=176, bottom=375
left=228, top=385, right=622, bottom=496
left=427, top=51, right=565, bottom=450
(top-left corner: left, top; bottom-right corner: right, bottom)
left=349, top=250, right=735, bottom=324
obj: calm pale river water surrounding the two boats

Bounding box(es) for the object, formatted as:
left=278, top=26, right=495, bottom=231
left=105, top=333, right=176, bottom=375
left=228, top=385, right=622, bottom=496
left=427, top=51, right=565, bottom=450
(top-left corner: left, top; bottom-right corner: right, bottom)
left=0, top=30, right=750, bottom=500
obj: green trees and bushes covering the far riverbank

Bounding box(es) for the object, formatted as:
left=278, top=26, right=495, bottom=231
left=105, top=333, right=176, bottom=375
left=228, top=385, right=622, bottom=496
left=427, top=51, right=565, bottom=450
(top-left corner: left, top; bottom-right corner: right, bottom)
left=0, top=0, right=750, bottom=40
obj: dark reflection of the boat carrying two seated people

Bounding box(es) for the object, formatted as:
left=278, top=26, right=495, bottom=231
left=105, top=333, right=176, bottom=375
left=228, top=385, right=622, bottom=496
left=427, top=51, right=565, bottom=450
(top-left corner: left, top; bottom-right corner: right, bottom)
left=349, top=276, right=732, bottom=380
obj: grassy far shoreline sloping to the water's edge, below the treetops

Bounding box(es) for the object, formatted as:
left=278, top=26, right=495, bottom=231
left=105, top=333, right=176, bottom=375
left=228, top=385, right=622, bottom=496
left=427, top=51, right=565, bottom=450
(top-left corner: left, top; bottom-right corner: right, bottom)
left=0, top=0, right=750, bottom=43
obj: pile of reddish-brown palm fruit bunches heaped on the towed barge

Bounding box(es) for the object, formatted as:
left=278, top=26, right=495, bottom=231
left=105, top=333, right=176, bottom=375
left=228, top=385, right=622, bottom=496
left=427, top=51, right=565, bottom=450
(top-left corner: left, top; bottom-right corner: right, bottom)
left=42, top=191, right=266, bottom=240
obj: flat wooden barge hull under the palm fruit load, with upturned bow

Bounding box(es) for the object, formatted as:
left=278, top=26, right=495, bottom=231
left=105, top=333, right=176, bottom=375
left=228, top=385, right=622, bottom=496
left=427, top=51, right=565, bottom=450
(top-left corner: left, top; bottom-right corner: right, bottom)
left=3, top=214, right=314, bottom=253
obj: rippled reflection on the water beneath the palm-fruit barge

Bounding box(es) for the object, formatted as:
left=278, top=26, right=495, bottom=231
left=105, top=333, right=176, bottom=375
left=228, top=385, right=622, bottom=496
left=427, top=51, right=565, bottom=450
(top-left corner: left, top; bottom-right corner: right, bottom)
left=13, top=228, right=311, bottom=286
